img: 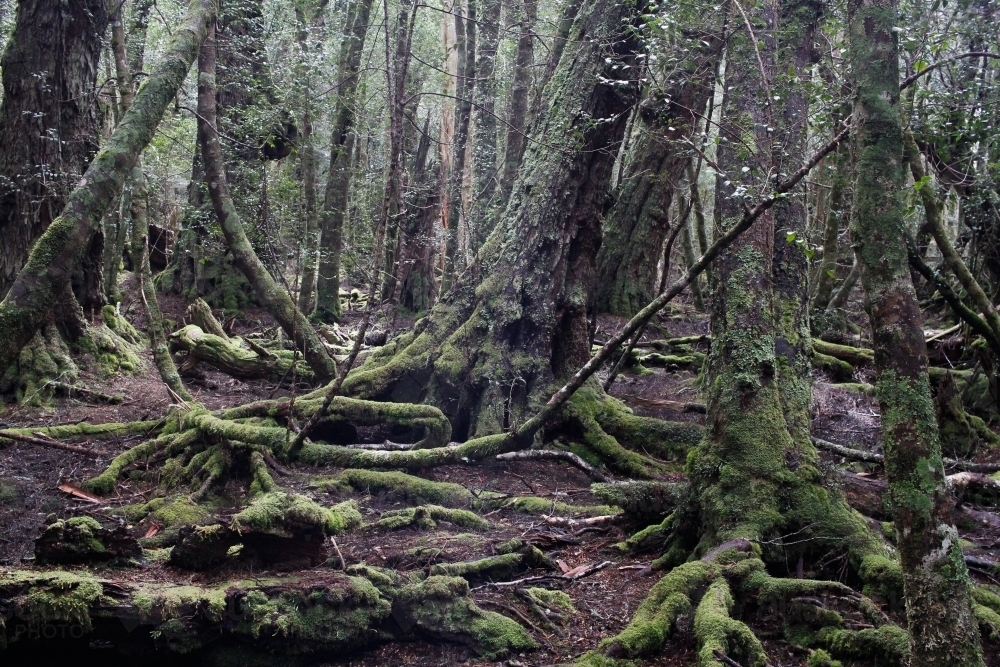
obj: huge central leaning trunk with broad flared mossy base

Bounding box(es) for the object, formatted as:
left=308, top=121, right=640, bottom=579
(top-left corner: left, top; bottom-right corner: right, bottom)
left=344, top=0, right=637, bottom=439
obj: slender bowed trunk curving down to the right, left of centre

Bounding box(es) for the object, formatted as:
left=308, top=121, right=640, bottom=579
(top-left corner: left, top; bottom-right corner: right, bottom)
left=198, top=20, right=337, bottom=382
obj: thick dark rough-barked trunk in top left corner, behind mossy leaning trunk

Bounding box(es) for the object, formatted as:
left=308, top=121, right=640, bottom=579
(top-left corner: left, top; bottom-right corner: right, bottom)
left=0, top=0, right=108, bottom=309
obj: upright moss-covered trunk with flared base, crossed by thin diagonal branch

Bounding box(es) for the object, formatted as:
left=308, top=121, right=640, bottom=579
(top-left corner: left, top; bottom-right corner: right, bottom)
left=684, top=3, right=884, bottom=567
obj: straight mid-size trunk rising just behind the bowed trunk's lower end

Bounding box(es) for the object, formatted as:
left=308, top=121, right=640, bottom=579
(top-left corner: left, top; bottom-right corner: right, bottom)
left=316, top=0, right=372, bottom=322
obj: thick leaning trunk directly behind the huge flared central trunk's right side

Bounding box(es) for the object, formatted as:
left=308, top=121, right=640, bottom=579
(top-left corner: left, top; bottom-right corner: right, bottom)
left=597, top=28, right=721, bottom=317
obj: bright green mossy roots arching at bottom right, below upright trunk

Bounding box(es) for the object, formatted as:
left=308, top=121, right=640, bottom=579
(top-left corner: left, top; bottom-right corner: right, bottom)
left=577, top=539, right=908, bottom=667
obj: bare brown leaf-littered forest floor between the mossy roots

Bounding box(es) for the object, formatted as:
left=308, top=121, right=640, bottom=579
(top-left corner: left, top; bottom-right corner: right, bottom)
left=0, top=297, right=1000, bottom=667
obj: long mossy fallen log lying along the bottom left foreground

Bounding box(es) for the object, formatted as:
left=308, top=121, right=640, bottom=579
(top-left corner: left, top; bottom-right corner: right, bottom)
left=0, top=567, right=536, bottom=664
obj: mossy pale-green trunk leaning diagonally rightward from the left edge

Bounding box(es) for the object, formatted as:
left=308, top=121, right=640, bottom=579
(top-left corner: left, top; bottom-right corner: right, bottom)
left=0, top=0, right=216, bottom=376
